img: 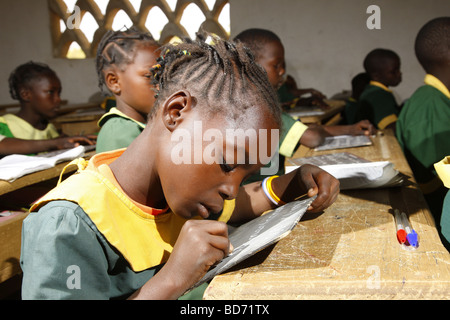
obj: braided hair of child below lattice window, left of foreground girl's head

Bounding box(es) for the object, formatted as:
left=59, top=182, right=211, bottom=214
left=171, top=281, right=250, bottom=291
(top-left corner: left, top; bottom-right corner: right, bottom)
left=96, top=27, right=159, bottom=94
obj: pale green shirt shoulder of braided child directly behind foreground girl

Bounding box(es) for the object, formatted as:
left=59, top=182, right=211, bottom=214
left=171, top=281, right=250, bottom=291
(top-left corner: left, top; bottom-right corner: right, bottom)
left=96, top=117, right=143, bottom=152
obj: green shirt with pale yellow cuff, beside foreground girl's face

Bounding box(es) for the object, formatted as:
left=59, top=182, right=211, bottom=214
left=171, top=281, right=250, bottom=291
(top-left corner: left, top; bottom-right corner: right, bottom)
left=243, top=112, right=308, bottom=184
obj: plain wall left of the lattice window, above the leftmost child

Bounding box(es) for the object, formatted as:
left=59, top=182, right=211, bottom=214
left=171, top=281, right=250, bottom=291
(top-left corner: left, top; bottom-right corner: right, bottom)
left=0, top=0, right=99, bottom=104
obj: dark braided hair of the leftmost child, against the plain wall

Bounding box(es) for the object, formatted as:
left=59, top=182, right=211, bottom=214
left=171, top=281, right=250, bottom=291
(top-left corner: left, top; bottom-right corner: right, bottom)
left=8, top=61, right=57, bottom=101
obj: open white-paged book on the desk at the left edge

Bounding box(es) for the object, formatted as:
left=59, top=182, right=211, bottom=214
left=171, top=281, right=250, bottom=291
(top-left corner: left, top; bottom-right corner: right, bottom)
left=0, top=146, right=95, bottom=182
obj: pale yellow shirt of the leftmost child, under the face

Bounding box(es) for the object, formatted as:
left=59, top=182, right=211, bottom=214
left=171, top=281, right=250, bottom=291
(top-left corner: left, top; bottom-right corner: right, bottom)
left=0, top=113, right=59, bottom=140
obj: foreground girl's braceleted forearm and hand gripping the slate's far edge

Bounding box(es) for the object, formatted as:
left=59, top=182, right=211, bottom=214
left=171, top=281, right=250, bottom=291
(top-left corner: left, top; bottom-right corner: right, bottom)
left=230, top=165, right=339, bottom=223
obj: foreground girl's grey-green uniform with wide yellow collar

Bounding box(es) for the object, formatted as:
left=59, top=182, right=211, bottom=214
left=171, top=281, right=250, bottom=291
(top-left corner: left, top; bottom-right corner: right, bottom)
left=20, top=149, right=234, bottom=299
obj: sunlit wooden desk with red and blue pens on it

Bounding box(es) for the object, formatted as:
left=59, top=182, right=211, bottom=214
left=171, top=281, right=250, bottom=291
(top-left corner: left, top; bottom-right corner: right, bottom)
left=204, top=132, right=450, bottom=300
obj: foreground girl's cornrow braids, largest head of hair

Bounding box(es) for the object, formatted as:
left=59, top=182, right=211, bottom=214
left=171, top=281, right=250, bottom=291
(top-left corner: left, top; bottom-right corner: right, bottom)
left=149, top=35, right=281, bottom=124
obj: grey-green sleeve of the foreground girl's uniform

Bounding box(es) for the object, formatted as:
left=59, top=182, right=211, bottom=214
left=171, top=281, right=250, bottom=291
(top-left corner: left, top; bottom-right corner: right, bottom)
left=21, top=201, right=110, bottom=300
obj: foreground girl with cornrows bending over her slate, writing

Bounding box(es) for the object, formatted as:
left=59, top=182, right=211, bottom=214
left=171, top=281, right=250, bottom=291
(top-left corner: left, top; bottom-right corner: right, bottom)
left=21, top=35, right=339, bottom=299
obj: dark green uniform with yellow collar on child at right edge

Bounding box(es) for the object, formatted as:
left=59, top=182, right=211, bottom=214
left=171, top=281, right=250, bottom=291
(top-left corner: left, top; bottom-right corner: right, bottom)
left=396, top=74, right=450, bottom=220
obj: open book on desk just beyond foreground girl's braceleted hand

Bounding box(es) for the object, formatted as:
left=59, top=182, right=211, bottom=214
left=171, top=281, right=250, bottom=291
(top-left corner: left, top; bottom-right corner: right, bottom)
left=286, top=152, right=405, bottom=190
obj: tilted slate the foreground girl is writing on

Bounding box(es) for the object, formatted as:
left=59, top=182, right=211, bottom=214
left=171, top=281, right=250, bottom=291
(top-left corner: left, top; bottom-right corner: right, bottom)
left=194, top=197, right=315, bottom=288
